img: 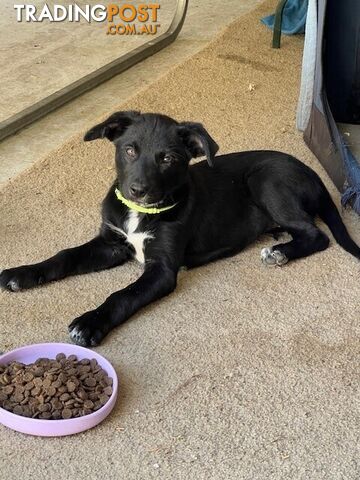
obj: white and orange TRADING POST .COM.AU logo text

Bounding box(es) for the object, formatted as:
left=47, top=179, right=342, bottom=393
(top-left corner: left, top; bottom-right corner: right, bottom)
left=14, top=3, right=160, bottom=35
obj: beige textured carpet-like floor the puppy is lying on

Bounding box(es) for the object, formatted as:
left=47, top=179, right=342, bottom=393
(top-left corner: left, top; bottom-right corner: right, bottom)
left=0, top=0, right=360, bottom=480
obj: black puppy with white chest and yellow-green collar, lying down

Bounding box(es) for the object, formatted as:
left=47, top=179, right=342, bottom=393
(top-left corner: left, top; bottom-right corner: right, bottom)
left=0, top=111, right=360, bottom=345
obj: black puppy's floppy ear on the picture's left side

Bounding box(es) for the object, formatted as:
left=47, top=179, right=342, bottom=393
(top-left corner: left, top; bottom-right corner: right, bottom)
left=84, top=110, right=140, bottom=142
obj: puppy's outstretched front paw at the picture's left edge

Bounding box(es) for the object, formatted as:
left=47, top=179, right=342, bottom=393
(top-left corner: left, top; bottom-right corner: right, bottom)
left=0, top=265, right=44, bottom=292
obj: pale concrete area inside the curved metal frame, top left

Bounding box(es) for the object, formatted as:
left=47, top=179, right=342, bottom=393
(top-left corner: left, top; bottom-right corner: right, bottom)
left=0, top=0, right=176, bottom=121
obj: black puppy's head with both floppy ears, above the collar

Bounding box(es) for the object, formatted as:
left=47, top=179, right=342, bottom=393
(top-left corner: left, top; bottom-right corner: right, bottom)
left=84, top=111, right=219, bottom=205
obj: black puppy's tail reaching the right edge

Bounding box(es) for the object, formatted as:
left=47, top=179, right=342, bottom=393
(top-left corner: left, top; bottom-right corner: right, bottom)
left=319, top=186, right=360, bottom=259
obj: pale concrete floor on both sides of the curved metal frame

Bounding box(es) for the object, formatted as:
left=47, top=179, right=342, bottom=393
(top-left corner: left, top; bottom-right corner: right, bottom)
left=0, top=0, right=264, bottom=187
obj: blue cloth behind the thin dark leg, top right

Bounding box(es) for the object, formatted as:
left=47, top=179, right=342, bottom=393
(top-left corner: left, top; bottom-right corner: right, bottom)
left=261, top=0, right=308, bottom=35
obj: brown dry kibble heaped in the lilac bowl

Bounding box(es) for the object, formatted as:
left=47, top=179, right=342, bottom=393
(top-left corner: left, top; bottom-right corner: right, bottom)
left=0, top=353, right=113, bottom=420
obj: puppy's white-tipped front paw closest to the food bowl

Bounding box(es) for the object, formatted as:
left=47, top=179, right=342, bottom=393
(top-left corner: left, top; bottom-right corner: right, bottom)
left=69, top=310, right=110, bottom=347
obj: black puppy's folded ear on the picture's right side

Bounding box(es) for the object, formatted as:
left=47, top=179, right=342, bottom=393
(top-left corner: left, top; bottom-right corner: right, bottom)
left=178, top=122, right=219, bottom=167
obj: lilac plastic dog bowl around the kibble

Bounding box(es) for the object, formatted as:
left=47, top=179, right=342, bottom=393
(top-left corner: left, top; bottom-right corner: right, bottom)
left=0, top=343, right=118, bottom=437
